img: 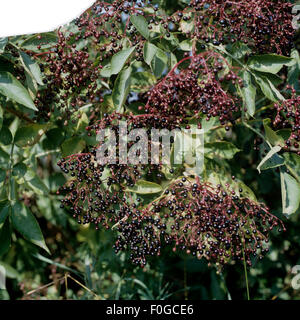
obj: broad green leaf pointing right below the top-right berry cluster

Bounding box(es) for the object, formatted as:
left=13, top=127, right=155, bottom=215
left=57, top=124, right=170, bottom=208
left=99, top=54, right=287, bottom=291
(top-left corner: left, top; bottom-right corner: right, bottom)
left=248, top=54, right=293, bottom=74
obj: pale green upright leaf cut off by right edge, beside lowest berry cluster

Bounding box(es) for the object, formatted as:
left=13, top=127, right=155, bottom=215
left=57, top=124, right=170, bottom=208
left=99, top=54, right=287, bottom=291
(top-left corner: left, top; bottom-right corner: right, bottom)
left=280, top=171, right=300, bottom=216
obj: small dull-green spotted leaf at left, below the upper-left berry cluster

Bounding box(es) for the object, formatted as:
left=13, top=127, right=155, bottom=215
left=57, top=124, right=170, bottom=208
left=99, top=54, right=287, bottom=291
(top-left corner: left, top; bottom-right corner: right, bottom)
left=15, top=124, right=47, bottom=147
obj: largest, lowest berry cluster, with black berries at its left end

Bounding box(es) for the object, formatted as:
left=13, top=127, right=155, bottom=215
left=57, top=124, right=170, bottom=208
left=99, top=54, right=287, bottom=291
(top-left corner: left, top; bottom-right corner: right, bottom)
left=114, top=178, right=284, bottom=266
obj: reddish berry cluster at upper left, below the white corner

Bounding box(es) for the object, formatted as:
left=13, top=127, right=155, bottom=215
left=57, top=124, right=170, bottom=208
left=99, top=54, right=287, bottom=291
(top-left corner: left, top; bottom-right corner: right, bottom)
left=35, top=31, right=103, bottom=121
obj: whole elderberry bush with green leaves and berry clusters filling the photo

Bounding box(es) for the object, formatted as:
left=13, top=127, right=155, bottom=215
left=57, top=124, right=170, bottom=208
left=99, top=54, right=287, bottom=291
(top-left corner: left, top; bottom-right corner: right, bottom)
left=0, top=0, right=300, bottom=299
